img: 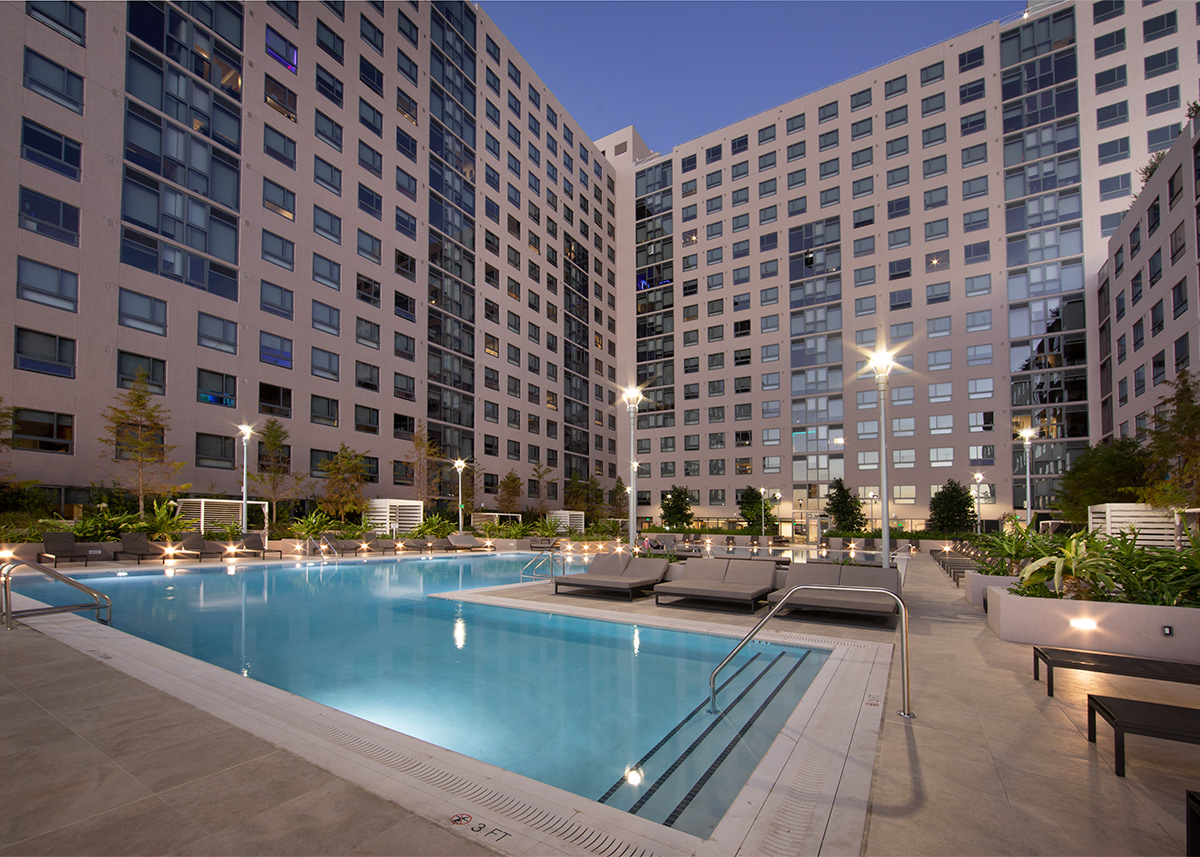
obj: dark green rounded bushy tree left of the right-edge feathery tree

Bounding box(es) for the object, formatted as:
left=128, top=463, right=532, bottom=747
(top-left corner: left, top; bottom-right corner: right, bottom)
left=1054, top=438, right=1148, bottom=523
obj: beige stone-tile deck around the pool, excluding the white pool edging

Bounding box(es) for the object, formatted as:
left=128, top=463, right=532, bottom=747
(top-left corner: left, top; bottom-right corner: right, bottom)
left=0, top=553, right=1200, bottom=857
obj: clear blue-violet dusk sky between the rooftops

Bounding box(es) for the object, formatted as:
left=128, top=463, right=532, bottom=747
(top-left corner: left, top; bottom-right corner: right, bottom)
left=480, top=0, right=1025, bottom=152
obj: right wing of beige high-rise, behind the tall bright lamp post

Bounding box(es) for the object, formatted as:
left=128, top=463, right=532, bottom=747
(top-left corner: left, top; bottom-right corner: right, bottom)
left=609, top=0, right=1200, bottom=535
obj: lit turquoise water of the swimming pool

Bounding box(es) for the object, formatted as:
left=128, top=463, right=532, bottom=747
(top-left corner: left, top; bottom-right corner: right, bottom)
left=17, top=555, right=828, bottom=837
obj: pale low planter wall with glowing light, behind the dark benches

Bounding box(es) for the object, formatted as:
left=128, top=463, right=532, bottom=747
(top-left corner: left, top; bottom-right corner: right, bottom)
left=988, top=587, right=1200, bottom=664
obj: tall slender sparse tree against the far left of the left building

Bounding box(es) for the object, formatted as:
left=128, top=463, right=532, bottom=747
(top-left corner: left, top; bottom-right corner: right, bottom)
left=100, top=371, right=191, bottom=520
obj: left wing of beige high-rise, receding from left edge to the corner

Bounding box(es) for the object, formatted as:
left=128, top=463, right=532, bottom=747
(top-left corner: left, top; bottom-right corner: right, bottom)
left=9, top=0, right=618, bottom=508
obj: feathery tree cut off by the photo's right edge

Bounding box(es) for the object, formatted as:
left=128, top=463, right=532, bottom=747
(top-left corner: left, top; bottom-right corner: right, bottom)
left=1141, top=370, right=1200, bottom=509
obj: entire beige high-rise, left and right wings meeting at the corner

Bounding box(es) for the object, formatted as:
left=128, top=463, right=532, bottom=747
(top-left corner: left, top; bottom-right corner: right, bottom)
left=0, top=0, right=1200, bottom=534
